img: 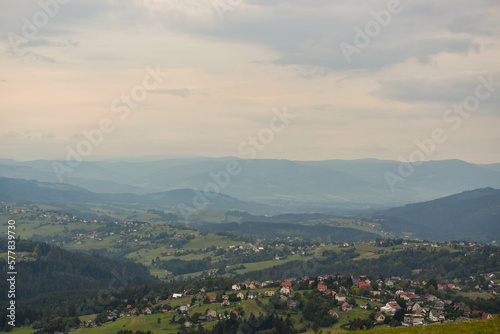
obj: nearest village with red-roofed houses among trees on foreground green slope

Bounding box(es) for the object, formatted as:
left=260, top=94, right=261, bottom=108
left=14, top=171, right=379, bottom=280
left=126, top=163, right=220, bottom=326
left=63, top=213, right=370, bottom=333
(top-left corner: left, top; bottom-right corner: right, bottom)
left=80, top=273, right=499, bottom=328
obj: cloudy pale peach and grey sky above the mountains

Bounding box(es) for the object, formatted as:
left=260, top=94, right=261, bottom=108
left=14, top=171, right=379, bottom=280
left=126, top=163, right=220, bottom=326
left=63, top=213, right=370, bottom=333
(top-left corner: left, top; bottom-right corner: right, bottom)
left=0, top=0, right=500, bottom=163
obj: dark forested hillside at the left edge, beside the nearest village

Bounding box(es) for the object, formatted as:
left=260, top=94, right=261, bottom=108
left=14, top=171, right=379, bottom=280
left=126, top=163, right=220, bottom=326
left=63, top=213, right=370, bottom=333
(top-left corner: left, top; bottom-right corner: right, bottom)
left=0, top=239, right=156, bottom=302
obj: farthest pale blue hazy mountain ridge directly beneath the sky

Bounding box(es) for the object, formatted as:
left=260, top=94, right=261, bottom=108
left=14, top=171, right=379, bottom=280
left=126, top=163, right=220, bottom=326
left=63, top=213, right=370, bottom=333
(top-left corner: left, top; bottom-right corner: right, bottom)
left=0, top=157, right=500, bottom=212
